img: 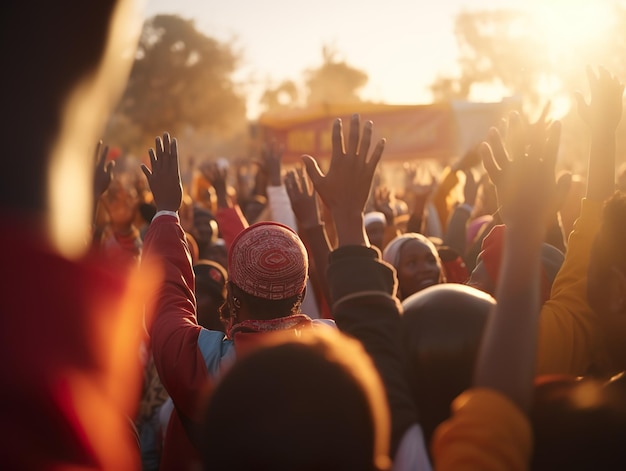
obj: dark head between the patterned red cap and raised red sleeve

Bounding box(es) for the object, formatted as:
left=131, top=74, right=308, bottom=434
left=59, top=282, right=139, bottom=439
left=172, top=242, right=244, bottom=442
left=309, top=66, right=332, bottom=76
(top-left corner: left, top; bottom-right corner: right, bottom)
left=193, top=260, right=227, bottom=332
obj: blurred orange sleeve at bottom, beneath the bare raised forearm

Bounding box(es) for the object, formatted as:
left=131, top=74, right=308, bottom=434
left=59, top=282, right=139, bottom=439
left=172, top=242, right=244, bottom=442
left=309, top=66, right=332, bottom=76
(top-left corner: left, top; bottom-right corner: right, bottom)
left=432, top=388, right=532, bottom=471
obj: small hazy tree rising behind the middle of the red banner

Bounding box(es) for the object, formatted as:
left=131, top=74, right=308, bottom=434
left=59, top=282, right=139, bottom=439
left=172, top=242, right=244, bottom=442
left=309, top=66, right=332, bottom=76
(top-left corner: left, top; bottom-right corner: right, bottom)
left=305, top=46, right=368, bottom=105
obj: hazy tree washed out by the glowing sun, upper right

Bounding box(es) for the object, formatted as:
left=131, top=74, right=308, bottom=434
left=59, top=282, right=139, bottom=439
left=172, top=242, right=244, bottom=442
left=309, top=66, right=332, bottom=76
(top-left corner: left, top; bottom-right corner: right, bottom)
left=431, top=2, right=626, bottom=108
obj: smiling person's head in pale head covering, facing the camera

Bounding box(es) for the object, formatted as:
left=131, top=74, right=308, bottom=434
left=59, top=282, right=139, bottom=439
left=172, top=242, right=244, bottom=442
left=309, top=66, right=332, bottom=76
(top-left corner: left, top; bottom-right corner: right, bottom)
left=383, top=232, right=446, bottom=299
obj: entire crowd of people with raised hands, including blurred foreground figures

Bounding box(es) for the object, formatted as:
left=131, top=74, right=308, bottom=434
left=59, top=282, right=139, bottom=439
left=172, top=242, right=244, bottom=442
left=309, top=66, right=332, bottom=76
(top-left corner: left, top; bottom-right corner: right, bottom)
left=0, top=0, right=626, bottom=471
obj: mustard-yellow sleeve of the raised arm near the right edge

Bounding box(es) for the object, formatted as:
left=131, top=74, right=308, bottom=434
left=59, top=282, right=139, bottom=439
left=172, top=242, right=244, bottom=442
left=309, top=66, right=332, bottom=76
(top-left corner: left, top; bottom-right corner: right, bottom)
left=537, top=199, right=602, bottom=376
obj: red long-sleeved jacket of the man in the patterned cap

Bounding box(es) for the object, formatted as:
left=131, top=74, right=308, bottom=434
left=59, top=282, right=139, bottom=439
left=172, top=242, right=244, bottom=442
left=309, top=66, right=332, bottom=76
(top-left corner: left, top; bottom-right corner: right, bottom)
left=143, top=215, right=322, bottom=470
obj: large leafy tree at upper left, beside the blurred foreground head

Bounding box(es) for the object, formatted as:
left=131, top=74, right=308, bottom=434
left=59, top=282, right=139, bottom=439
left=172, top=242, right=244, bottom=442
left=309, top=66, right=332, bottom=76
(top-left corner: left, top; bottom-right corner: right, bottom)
left=107, top=15, right=246, bottom=157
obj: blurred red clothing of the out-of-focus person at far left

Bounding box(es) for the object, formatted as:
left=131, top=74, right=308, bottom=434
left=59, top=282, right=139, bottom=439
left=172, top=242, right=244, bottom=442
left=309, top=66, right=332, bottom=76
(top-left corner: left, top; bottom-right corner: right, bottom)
left=0, top=224, right=149, bottom=470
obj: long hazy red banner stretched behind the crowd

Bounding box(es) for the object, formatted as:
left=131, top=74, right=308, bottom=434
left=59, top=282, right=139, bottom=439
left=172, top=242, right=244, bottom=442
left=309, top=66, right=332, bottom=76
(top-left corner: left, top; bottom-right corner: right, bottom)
left=258, top=103, right=510, bottom=163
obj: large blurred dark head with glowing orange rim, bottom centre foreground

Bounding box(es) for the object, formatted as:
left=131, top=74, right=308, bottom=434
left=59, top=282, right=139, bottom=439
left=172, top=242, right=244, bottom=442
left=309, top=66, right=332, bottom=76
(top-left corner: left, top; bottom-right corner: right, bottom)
left=202, top=328, right=389, bottom=471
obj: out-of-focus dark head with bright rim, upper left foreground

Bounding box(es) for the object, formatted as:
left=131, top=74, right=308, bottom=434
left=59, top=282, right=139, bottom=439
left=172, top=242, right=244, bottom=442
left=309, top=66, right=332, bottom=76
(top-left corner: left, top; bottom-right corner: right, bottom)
left=0, top=0, right=143, bottom=255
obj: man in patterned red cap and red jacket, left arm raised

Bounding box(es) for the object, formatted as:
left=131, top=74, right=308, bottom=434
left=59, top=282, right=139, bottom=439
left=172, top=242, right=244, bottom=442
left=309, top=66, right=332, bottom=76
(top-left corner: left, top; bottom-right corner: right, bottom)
left=143, top=134, right=321, bottom=470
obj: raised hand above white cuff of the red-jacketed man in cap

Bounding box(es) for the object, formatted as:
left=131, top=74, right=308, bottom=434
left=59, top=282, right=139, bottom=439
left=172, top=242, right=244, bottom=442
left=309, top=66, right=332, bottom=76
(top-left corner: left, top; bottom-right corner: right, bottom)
left=141, top=133, right=183, bottom=211
